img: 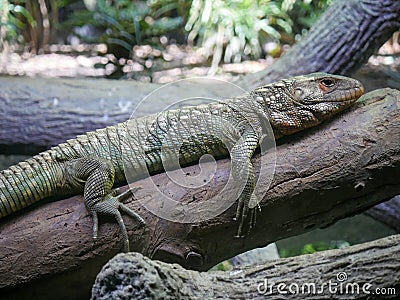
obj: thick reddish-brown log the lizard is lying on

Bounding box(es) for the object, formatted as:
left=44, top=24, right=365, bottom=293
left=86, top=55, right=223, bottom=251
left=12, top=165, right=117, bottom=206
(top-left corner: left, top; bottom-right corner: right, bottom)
left=0, top=89, right=400, bottom=298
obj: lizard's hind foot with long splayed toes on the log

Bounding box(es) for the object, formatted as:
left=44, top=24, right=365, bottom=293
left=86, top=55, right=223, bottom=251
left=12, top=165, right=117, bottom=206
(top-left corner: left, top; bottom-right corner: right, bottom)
left=91, top=190, right=145, bottom=252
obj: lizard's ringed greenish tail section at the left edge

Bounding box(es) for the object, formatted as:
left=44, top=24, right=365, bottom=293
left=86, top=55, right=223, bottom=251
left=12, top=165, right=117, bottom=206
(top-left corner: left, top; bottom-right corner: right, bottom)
left=0, top=152, right=60, bottom=218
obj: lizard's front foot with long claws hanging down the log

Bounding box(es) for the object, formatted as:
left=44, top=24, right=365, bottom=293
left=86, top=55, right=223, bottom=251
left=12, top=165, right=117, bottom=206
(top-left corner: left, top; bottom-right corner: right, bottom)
left=235, top=194, right=261, bottom=238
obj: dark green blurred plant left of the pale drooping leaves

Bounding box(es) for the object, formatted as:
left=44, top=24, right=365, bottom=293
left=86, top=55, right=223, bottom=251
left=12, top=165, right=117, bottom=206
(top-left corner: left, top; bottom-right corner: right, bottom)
left=63, top=0, right=190, bottom=57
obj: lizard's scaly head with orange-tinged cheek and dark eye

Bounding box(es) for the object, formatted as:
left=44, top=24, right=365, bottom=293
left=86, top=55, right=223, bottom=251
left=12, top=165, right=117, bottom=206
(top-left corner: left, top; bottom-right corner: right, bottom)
left=256, top=73, right=364, bottom=138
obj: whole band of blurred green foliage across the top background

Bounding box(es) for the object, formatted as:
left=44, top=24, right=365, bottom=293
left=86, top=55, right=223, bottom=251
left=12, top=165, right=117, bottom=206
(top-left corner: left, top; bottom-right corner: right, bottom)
left=0, top=0, right=333, bottom=77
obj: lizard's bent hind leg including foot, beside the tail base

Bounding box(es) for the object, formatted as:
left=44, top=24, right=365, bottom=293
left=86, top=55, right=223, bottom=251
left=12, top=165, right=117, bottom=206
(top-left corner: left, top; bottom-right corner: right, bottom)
left=62, top=157, right=145, bottom=252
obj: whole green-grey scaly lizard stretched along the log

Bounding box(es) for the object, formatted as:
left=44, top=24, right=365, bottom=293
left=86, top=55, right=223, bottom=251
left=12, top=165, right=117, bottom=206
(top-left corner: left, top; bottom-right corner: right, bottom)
left=0, top=73, right=364, bottom=251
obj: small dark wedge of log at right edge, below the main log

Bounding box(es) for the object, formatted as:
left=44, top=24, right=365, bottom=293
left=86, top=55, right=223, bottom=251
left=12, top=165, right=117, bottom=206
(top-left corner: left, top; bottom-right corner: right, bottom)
left=365, top=195, right=400, bottom=233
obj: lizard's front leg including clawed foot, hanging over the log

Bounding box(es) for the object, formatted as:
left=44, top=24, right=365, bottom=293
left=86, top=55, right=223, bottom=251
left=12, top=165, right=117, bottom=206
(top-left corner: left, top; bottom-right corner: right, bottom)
left=230, top=128, right=259, bottom=237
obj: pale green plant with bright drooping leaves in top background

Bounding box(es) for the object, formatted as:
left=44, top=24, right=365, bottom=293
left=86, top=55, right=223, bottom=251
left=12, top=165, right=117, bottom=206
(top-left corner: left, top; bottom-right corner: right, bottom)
left=185, top=0, right=291, bottom=73
